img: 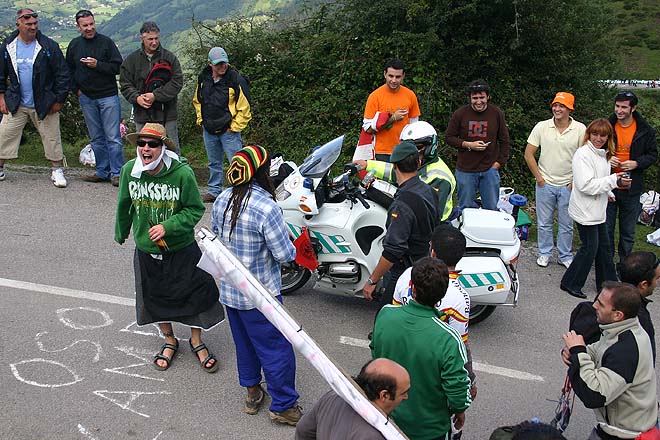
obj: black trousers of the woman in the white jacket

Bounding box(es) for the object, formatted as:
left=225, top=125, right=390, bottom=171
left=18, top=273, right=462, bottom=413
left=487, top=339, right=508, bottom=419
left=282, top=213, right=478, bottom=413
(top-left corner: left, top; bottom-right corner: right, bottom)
left=561, top=223, right=617, bottom=291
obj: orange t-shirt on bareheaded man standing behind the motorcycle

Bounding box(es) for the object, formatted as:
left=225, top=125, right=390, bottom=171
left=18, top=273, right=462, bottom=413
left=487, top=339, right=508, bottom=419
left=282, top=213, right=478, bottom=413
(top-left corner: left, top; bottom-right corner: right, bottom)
left=364, top=84, right=420, bottom=154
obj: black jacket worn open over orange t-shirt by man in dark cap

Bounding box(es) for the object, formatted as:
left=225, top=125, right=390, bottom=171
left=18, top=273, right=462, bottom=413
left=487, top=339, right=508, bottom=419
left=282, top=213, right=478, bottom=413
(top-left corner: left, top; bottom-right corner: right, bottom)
left=610, top=111, right=658, bottom=194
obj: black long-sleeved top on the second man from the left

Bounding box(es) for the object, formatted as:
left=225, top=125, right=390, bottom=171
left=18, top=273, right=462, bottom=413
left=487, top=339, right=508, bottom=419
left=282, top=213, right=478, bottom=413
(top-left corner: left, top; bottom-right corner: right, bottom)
left=66, top=33, right=122, bottom=99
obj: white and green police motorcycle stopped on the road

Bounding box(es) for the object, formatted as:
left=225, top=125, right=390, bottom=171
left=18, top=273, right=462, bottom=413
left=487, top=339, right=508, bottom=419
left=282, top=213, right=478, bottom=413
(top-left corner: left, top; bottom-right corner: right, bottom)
left=271, top=131, right=520, bottom=323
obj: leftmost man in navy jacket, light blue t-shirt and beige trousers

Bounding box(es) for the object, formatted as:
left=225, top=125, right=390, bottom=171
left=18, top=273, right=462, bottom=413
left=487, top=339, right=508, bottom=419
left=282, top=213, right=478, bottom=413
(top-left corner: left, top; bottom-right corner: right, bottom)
left=0, top=8, right=71, bottom=188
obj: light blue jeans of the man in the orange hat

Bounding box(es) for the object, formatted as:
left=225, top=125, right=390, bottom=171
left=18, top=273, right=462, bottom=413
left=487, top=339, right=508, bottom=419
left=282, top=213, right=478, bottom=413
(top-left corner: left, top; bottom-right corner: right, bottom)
left=536, top=183, right=573, bottom=261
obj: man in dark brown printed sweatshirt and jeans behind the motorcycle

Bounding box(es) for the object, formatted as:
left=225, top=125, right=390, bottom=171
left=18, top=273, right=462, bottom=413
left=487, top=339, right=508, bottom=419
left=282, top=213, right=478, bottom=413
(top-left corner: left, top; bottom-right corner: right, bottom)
left=445, top=79, right=510, bottom=211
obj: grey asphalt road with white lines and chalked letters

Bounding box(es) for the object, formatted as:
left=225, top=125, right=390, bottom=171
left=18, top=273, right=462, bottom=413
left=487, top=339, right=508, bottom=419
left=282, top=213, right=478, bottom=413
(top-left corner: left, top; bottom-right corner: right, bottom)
left=0, top=168, right=657, bottom=440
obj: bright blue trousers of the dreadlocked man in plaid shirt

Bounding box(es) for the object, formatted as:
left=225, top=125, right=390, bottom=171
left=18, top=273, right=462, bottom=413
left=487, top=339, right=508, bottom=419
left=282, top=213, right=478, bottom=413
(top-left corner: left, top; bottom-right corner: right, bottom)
left=226, top=297, right=300, bottom=412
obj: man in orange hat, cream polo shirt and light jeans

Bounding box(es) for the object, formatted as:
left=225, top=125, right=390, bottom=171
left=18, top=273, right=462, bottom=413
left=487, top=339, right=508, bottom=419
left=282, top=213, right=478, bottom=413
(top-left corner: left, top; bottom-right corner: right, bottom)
left=525, top=92, right=586, bottom=267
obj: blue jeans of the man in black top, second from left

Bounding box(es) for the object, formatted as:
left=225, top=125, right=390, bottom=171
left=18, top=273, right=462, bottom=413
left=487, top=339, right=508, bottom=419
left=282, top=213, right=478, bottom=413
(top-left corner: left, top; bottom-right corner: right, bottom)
left=78, top=93, right=124, bottom=179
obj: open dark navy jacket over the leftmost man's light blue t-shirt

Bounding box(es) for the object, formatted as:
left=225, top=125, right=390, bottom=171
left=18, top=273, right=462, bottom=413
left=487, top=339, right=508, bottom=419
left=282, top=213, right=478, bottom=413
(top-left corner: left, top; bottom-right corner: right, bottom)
left=0, top=30, right=71, bottom=119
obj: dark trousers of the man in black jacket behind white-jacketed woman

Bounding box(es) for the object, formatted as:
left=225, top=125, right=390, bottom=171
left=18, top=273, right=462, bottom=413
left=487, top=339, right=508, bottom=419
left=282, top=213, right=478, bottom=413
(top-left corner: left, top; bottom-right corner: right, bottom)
left=606, top=189, right=642, bottom=261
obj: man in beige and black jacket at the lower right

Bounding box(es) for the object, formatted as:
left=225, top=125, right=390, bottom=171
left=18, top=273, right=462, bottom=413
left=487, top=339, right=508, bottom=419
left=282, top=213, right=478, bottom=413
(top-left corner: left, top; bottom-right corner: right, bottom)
left=561, top=282, right=658, bottom=440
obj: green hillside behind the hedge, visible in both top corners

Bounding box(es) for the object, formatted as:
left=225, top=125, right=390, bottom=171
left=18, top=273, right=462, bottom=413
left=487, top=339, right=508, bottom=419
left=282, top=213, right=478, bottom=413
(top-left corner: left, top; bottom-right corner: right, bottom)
left=0, top=0, right=660, bottom=79
